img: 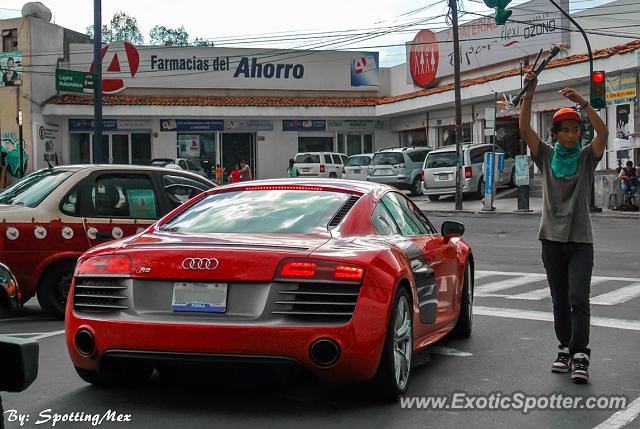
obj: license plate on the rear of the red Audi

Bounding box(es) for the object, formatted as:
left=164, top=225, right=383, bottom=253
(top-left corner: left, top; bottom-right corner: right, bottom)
left=171, top=282, right=228, bottom=313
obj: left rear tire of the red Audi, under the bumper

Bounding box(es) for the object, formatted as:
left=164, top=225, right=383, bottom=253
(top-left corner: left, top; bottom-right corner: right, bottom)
left=75, top=361, right=154, bottom=387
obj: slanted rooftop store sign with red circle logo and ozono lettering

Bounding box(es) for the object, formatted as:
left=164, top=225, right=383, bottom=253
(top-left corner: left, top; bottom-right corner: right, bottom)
left=406, top=0, right=571, bottom=88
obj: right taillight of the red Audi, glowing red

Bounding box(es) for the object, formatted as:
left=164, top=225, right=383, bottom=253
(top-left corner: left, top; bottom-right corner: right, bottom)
left=274, top=259, right=364, bottom=283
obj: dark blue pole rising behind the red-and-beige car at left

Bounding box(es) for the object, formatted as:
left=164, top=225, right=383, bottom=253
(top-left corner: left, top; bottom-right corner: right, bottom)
left=93, top=0, right=103, bottom=164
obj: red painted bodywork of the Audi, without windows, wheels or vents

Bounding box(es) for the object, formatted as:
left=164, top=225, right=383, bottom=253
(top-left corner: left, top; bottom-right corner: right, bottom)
left=65, top=180, right=471, bottom=381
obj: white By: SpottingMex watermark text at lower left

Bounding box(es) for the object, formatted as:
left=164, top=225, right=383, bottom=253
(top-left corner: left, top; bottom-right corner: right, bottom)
left=4, top=408, right=131, bottom=427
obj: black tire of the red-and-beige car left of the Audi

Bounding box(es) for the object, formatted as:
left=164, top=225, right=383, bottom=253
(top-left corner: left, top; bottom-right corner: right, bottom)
left=37, top=261, right=76, bottom=320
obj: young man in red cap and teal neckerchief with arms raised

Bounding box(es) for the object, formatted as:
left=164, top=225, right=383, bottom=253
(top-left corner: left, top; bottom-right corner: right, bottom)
left=520, top=72, right=609, bottom=383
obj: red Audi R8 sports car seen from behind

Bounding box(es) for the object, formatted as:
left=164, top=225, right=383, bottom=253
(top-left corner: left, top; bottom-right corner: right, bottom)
left=65, top=179, right=474, bottom=397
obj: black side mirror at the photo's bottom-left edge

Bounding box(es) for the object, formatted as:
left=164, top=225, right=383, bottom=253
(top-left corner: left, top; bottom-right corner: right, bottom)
left=0, top=335, right=39, bottom=392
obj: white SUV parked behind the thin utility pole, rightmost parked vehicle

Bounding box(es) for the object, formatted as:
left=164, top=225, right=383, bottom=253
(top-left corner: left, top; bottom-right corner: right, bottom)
left=422, top=144, right=515, bottom=201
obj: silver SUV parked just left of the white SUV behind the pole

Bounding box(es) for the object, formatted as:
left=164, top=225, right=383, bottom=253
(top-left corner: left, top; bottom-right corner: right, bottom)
left=367, top=146, right=432, bottom=196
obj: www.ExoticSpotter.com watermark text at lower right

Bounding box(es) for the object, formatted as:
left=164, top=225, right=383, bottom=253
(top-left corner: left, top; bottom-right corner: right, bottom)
left=400, top=392, right=629, bottom=414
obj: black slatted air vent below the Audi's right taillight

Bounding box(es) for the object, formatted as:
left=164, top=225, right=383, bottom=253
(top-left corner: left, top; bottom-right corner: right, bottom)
left=271, top=283, right=360, bottom=323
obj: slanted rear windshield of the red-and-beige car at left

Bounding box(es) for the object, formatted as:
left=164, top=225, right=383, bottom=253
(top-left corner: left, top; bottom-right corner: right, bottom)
left=0, top=169, right=74, bottom=207
